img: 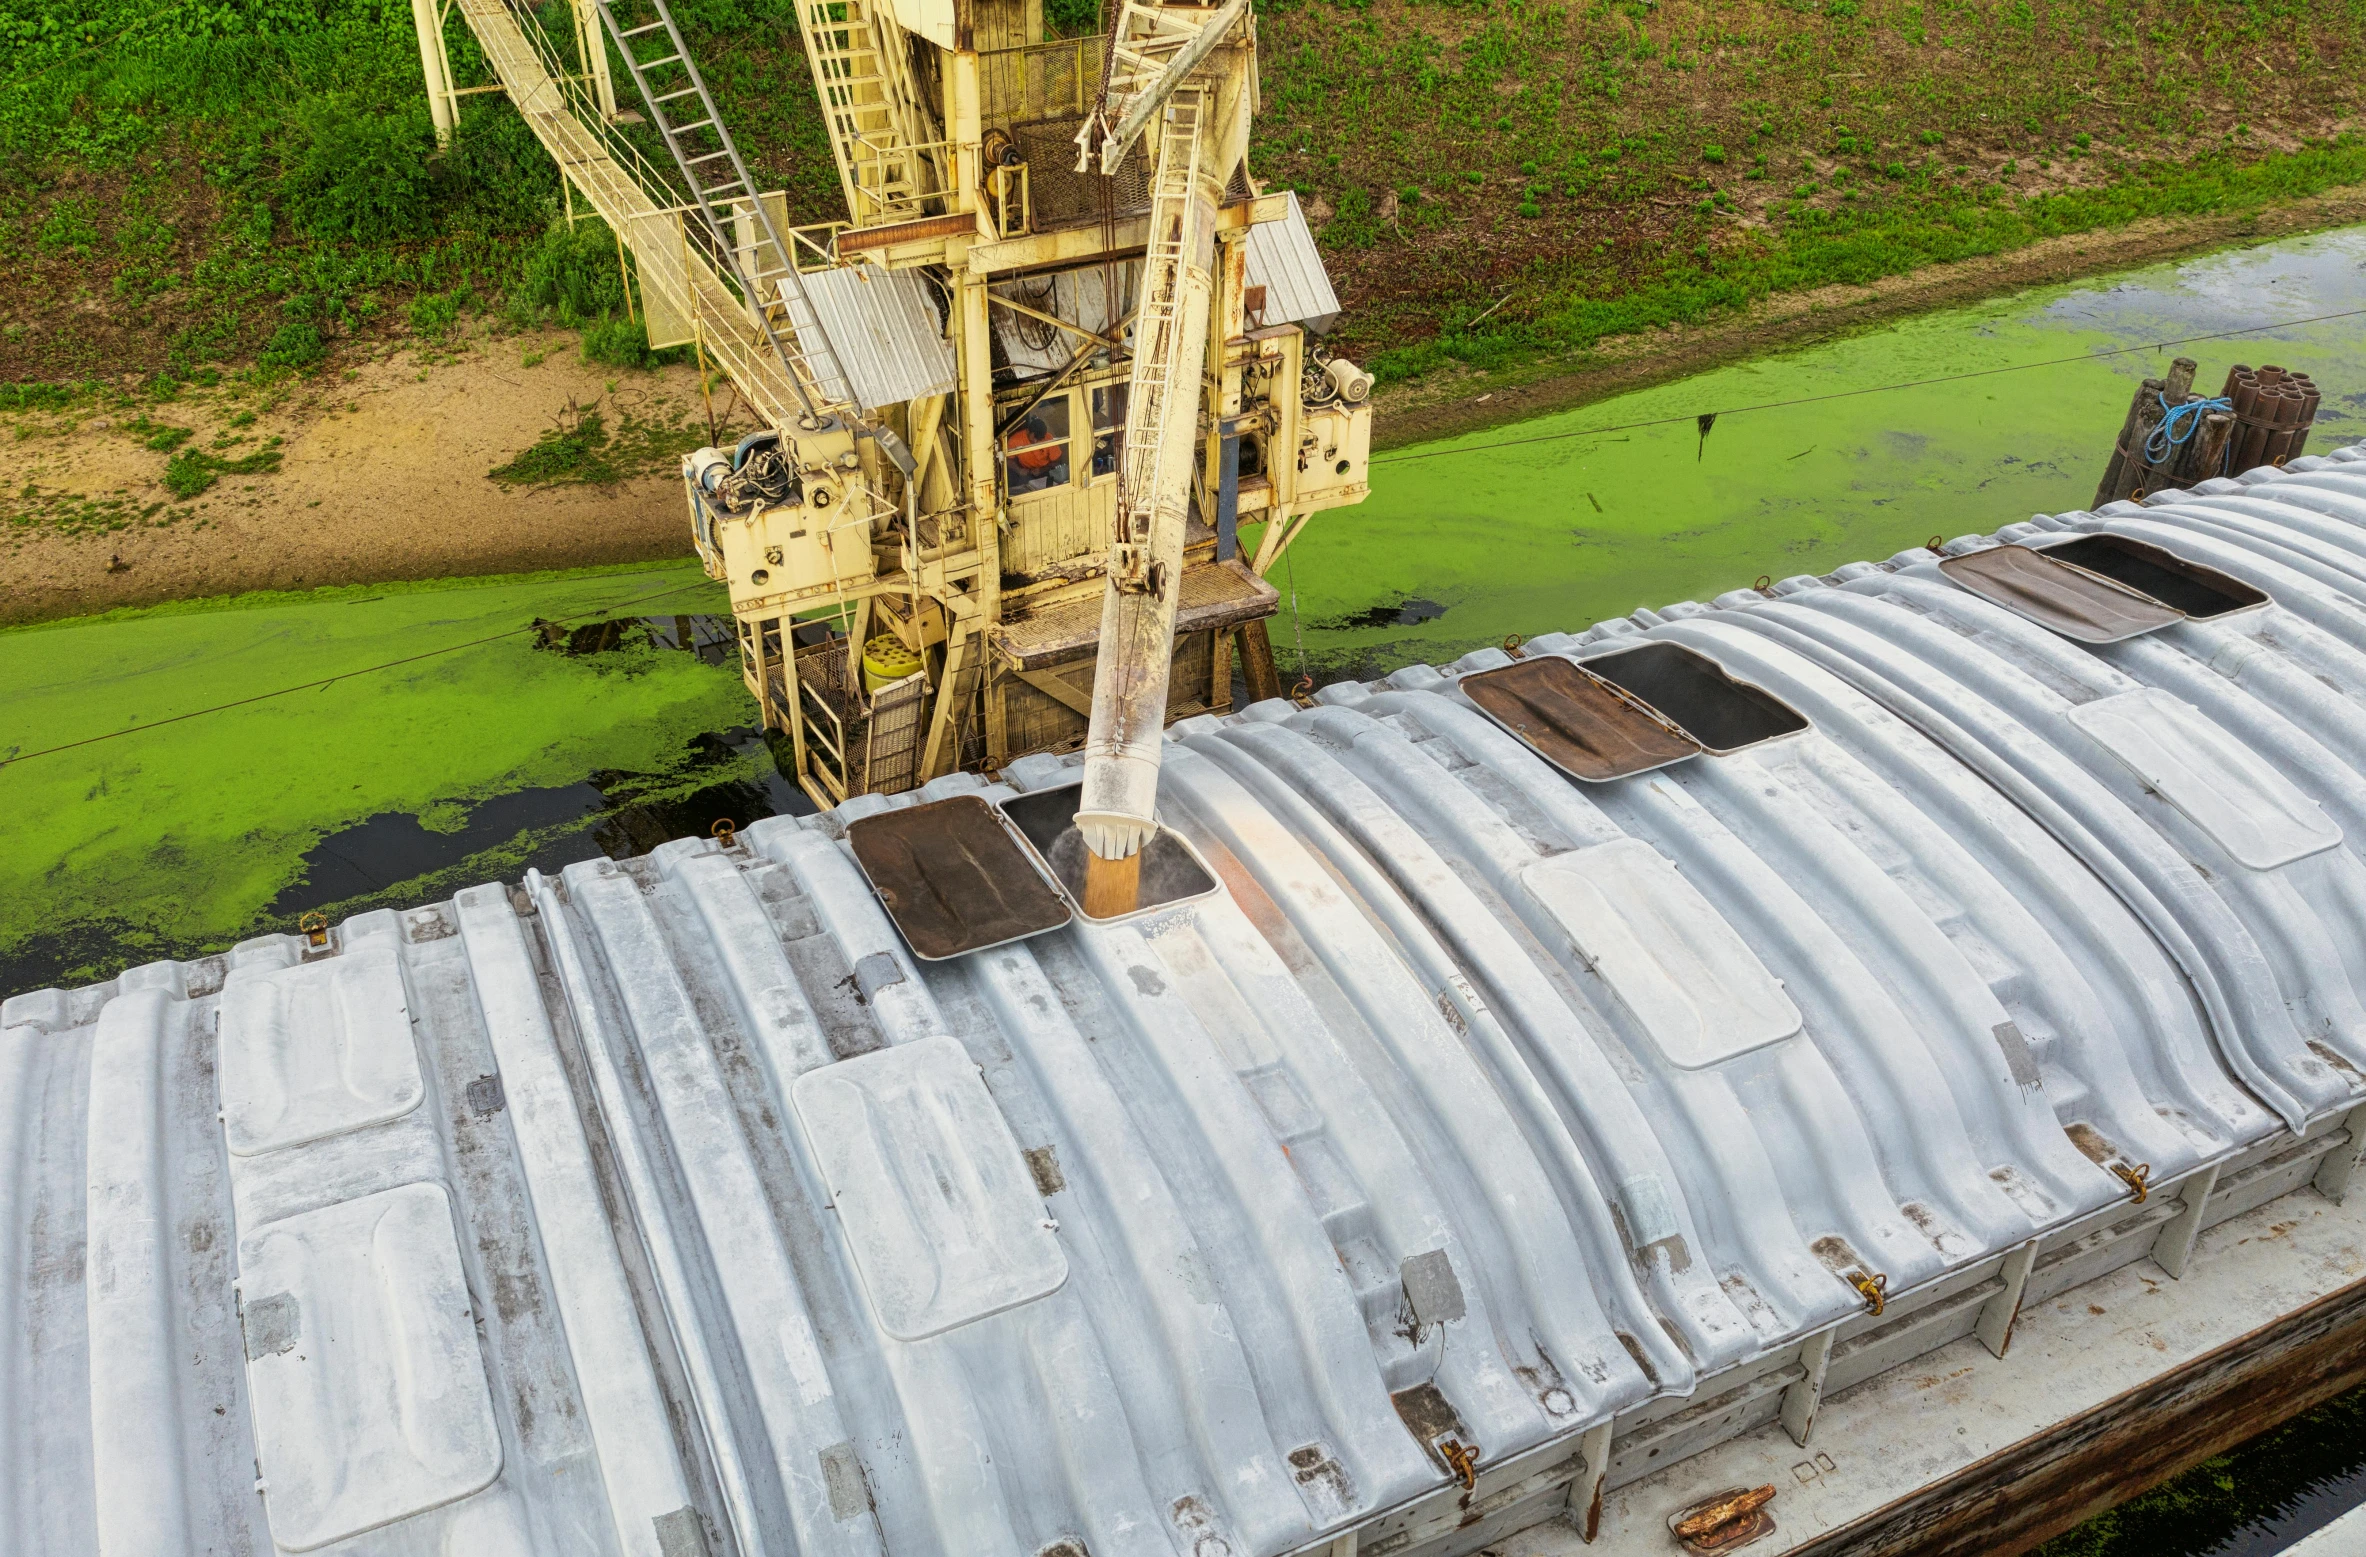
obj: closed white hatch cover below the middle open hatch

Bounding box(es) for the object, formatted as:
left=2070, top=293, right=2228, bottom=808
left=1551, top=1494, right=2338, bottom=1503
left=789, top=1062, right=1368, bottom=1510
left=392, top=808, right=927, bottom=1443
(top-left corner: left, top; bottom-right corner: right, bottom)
left=1521, top=838, right=1801, bottom=1070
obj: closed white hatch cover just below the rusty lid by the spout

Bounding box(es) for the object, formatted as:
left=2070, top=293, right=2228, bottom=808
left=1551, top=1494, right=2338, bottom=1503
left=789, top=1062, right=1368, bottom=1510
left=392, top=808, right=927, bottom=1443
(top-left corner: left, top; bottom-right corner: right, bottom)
left=795, top=1039, right=1067, bottom=1342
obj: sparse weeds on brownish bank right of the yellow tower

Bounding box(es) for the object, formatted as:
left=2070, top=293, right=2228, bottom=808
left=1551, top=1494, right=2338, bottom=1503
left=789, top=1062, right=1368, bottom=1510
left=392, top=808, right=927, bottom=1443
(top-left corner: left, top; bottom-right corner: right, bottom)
left=1249, top=0, right=2366, bottom=381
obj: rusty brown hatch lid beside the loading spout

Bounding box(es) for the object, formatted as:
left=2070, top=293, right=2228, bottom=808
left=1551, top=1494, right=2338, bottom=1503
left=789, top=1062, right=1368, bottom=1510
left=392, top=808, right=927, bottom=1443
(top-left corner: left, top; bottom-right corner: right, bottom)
left=847, top=795, right=1069, bottom=961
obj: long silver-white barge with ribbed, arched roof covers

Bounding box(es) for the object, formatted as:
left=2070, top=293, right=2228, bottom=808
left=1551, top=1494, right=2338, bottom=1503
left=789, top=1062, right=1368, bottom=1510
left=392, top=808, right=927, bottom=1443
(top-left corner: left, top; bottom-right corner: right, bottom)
left=0, top=450, right=2366, bottom=1557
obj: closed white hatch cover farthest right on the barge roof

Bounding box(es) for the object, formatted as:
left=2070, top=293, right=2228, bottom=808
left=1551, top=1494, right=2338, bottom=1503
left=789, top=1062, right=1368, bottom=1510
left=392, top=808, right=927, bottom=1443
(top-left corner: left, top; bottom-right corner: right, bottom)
left=2070, top=686, right=2342, bottom=871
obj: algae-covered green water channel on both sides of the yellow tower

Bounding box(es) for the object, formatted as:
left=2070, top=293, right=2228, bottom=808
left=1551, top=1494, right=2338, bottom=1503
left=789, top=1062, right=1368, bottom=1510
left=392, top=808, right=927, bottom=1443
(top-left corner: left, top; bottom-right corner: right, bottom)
left=13, top=232, right=2366, bottom=994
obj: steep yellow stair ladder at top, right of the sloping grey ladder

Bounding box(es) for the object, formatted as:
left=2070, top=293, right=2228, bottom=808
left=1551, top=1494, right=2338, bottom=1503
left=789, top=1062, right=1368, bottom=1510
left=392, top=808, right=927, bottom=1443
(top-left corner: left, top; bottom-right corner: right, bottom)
left=797, top=0, right=935, bottom=227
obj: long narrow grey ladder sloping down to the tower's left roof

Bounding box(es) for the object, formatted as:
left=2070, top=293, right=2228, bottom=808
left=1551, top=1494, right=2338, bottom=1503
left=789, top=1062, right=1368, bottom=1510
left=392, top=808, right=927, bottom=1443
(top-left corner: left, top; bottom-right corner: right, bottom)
left=594, top=0, right=854, bottom=419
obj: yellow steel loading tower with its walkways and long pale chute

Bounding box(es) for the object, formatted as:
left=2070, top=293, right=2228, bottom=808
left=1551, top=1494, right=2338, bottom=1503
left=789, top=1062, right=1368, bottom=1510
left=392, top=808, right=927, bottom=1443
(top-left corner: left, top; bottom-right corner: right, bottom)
left=414, top=0, right=1370, bottom=813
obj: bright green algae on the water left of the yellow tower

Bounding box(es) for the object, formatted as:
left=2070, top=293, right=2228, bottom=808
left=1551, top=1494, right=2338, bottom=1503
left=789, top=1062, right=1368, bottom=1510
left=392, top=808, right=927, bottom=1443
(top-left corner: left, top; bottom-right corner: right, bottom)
left=0, top=563, right=748, bottom=989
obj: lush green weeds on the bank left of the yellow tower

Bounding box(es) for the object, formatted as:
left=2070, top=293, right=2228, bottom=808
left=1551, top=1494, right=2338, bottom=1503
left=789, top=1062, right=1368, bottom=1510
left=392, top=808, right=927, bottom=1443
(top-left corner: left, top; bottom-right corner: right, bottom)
left=0, top=0, right=813, bottom=376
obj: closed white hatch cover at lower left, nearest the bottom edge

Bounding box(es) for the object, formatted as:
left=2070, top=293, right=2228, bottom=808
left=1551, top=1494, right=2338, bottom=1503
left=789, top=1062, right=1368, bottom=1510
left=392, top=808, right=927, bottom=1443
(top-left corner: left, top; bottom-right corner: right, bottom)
left=239, top=1183, right=502, bottom=1552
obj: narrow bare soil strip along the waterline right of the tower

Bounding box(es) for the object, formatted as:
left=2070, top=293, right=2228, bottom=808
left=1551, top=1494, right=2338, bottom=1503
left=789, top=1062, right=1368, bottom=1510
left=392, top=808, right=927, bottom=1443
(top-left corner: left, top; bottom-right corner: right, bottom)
left=1372, top=185, right=2366, bottom=447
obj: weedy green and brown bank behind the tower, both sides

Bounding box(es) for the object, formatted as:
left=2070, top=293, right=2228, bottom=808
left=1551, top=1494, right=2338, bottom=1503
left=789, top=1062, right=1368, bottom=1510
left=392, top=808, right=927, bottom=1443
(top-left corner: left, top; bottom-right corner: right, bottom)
left=0, top=0, right=2366, bottom=397
